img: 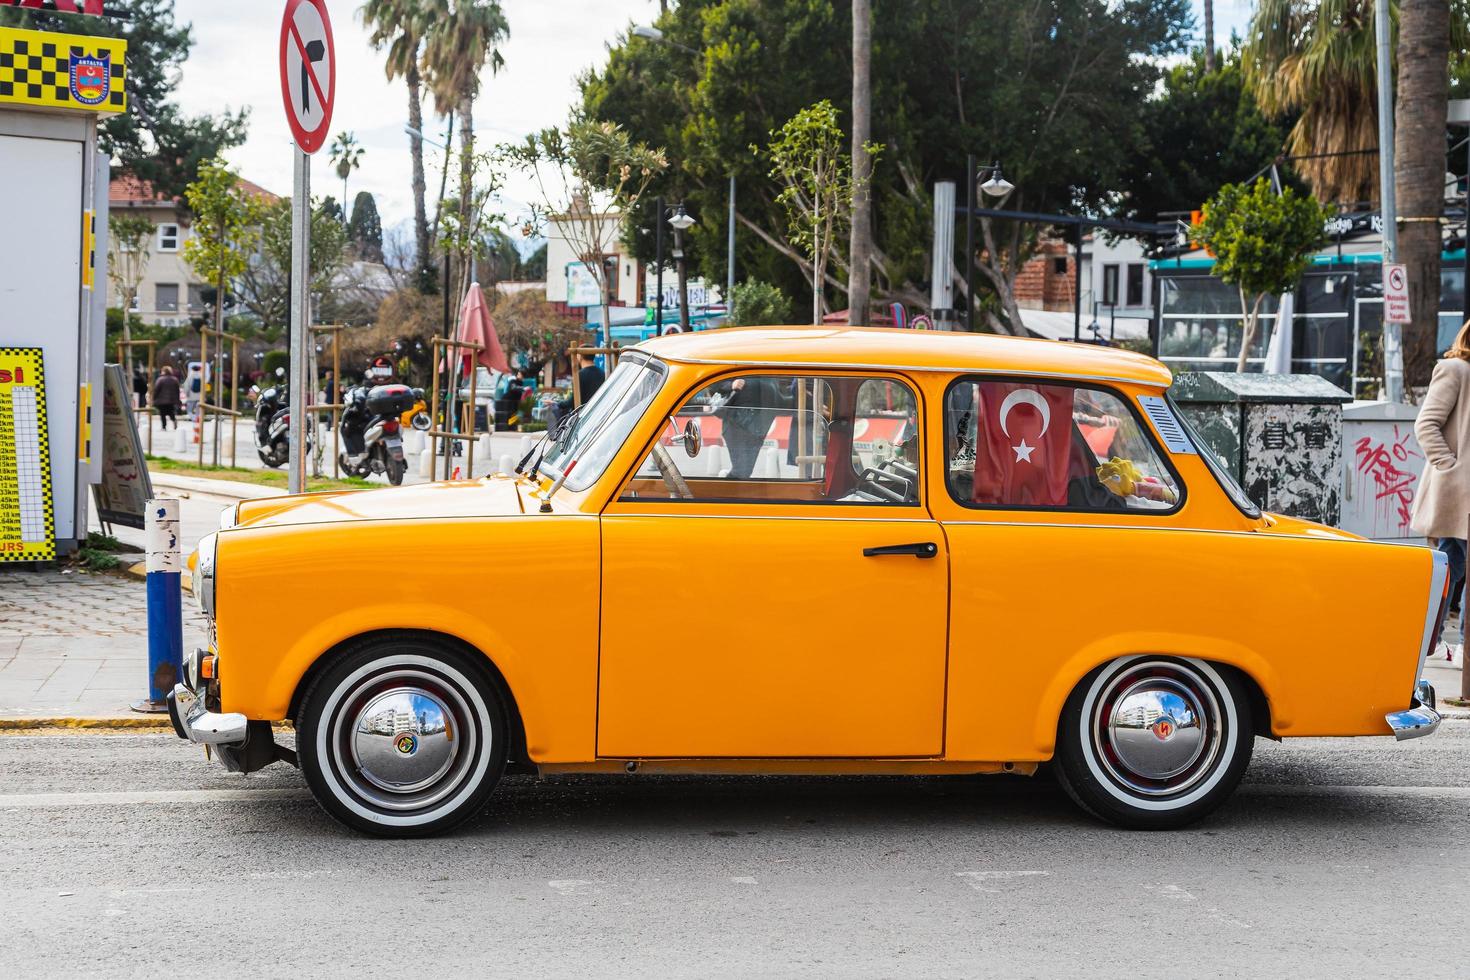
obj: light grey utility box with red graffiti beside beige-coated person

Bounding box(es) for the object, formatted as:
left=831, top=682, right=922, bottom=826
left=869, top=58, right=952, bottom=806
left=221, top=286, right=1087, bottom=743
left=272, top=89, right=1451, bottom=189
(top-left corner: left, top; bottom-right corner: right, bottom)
left=1342, top=401, right=1427, bottom=544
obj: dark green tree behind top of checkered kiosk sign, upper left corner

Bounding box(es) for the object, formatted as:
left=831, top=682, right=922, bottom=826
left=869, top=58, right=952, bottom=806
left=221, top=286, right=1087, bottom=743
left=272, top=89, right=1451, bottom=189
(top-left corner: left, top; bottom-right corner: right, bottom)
left=0, top=0, right=248, bottom=198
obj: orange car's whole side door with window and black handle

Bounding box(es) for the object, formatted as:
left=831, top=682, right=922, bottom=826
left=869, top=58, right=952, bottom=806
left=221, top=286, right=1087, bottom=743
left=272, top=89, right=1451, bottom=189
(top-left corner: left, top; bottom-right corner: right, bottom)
left=597, top=375, right=948, bottom=758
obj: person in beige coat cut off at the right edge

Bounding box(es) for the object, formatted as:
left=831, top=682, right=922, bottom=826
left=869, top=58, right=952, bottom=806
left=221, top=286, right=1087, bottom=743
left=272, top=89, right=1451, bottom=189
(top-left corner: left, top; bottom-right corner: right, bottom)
left=1410, top=320, right=1470, bottom=660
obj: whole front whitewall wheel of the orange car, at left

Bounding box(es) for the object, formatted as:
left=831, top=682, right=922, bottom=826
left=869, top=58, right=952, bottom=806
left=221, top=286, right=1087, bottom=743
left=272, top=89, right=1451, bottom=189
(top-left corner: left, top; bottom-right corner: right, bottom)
left=297, top=639, right=507, bottom=837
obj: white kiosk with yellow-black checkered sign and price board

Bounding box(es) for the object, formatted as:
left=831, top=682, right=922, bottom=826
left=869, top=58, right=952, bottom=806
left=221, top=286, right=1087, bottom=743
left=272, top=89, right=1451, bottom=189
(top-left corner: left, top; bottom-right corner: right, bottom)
left=0, top=28, right=126, bottom=563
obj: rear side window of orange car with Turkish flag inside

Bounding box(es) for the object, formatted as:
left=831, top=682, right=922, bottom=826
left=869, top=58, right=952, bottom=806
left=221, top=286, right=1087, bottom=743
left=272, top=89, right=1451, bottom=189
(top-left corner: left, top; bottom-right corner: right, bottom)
left=944, top=379, right=1180, bottom=511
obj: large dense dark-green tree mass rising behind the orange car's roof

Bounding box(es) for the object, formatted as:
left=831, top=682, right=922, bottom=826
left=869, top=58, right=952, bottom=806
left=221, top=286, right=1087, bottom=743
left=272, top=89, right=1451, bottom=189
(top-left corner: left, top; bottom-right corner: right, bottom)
left=582, top=0, right=1191, bottom=329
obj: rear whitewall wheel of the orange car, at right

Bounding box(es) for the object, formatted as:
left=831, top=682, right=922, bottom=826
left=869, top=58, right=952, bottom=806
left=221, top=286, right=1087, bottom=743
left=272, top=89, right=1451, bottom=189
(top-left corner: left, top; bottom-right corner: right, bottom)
left=1055, top=657, right=1254, bottom=830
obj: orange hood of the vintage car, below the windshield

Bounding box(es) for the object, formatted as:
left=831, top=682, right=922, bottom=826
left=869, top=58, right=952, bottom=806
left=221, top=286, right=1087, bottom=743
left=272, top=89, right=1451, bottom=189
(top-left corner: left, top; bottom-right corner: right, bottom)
left=235, top=476, right=535, bottom=527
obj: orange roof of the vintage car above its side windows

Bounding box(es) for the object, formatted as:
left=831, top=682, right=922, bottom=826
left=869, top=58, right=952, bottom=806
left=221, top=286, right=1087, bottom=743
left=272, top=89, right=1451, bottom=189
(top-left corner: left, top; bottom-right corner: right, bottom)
left=638, top=326, right=1173, bottom=388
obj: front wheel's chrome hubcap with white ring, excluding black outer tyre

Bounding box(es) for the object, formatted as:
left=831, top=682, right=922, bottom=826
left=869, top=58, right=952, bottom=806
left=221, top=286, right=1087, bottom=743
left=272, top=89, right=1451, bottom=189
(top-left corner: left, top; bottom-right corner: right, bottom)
left=331, top=667, right=490, bottom=813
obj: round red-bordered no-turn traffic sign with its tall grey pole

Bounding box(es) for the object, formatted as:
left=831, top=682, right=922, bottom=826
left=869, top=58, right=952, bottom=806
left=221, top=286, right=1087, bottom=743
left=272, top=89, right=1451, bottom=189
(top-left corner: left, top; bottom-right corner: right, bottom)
left=281, top=0, right=337, bottom=494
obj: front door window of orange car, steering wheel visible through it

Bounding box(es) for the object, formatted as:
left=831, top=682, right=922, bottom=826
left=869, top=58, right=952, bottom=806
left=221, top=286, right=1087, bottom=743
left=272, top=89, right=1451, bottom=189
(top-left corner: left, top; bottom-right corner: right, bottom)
left=622, top=375, right=920, bottom=505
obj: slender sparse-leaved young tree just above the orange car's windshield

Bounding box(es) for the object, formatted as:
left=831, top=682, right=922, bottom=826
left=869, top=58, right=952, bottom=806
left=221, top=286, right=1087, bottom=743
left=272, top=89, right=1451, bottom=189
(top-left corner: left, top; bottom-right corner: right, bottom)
left=506, top=118, right=669, bottom=333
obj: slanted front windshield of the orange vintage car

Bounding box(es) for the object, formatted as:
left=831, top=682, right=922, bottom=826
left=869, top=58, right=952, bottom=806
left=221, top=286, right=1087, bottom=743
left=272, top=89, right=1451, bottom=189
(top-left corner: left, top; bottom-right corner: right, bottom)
left=541, top=354, right=667, bottom=491
